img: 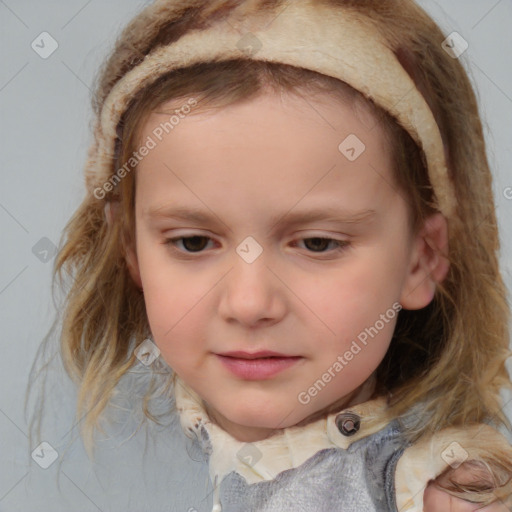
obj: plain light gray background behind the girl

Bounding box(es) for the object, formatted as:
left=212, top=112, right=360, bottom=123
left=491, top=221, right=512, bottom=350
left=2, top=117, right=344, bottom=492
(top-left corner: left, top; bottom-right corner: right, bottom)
left=0, top=0, right=512, bottom=512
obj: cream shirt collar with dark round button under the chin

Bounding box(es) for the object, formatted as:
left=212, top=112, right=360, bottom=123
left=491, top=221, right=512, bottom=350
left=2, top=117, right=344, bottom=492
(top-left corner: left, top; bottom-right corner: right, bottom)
left=174, top=375, right=391, bottom=484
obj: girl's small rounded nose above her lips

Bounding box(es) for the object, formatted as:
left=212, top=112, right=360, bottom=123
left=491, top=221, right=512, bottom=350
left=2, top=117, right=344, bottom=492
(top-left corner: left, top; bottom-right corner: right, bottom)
left=218, top=251, right=286, bottom=327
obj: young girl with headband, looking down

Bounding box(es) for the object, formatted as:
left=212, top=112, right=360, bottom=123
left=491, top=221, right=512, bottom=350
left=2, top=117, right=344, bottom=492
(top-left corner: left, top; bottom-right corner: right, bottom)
left=29, top=0, right=512, bottom=512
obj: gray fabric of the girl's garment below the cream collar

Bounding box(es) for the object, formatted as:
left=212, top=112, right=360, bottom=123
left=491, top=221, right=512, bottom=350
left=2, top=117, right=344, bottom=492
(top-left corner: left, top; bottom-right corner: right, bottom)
left=208, top=421, right=406, bottom=512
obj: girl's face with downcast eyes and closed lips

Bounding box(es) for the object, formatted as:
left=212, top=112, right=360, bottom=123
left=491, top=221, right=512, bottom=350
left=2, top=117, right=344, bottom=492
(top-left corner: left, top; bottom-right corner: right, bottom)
left=132, top=88, right=432, bottom=440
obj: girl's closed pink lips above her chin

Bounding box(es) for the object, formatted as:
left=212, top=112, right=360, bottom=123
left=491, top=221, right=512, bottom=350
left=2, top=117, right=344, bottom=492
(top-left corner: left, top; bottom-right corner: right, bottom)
left=215, top=351, right=303, bottom=380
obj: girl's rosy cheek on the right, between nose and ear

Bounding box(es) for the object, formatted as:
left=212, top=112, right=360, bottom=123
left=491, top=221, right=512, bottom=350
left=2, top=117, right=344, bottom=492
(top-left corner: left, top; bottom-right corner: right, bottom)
left=297, top=257, right=401, bottom=368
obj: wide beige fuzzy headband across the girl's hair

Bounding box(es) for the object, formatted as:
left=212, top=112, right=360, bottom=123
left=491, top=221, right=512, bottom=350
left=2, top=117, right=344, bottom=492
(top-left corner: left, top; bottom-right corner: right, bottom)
left=85, top=0, right=456, bottom=217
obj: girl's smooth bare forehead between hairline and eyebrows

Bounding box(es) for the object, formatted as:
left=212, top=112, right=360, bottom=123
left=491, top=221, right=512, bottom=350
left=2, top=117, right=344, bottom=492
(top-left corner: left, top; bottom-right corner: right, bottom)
left=133, top=89, right=396, bottom=224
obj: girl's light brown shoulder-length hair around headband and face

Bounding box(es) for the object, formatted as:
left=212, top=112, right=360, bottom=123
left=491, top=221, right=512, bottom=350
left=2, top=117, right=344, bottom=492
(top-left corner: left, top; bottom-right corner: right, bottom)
left=29, top=0, right=512, bottom=502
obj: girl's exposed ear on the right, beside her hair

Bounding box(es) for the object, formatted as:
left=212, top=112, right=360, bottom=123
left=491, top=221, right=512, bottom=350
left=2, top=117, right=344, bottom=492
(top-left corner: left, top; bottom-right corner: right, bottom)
left=400, top=213, right=450, bottom=310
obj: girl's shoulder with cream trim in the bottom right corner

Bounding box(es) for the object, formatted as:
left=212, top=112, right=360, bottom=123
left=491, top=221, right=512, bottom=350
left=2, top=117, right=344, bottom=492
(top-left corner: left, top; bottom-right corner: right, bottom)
left=395, top=424, right=512, bottom=512
